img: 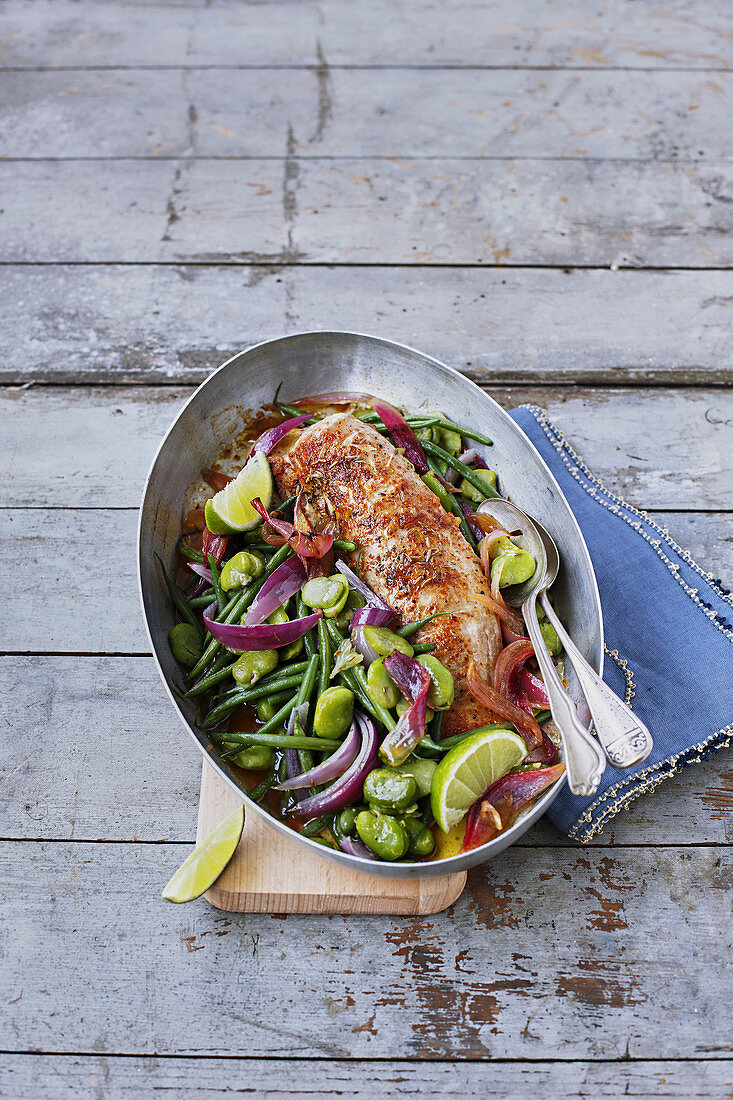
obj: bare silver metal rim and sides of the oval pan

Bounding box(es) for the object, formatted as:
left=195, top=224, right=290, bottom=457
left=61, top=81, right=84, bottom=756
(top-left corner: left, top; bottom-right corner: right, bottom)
left=138, top=332, right=603, bottom=878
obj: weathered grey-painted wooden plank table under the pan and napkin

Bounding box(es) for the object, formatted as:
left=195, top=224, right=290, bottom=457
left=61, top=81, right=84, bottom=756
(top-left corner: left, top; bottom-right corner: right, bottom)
left=0, top=0, right=733, bottom=1100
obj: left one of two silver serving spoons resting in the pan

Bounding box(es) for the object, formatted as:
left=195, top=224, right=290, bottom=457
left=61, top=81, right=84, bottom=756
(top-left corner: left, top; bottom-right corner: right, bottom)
left=479, top=497, right=605, bottom=798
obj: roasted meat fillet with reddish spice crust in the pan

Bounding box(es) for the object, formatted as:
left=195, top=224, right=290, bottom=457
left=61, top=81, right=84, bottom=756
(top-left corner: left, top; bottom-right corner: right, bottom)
left=270, top=414, right=502, bottom=734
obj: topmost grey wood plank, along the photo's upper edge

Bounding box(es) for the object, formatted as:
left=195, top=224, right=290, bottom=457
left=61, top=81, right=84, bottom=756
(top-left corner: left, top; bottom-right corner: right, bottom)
left=0, top=0, right=731, bottom=69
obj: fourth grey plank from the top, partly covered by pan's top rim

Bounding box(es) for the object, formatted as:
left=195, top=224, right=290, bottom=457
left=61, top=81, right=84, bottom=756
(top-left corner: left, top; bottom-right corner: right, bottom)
left=0, top=265, right=733, bottom=385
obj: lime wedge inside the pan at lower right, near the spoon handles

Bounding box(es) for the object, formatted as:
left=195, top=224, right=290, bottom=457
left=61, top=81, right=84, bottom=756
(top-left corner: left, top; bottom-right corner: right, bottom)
left=430, top=729, right=527, bottom=833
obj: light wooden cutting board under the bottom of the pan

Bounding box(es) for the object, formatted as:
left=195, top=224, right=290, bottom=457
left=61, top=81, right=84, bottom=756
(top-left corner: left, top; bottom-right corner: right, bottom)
left=196, top=760, right=466, bottom=916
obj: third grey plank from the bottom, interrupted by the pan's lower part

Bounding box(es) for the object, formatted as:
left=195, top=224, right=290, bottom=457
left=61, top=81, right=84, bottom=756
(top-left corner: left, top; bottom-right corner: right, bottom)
left=0, top=656, right=733, bottom=851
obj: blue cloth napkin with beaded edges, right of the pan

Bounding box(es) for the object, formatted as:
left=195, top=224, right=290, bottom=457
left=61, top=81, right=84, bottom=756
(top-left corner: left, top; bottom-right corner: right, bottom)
left=511, top=405, right=733, bottom=843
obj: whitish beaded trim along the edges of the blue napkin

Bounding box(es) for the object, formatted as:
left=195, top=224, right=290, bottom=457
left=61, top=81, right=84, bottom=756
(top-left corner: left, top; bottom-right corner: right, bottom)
left=521, top=405, right=733, bottom=844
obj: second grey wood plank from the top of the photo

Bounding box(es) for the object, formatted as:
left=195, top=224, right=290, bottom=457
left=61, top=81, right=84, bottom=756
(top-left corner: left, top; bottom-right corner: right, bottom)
left=0, top=64, right=733, bottom=161
